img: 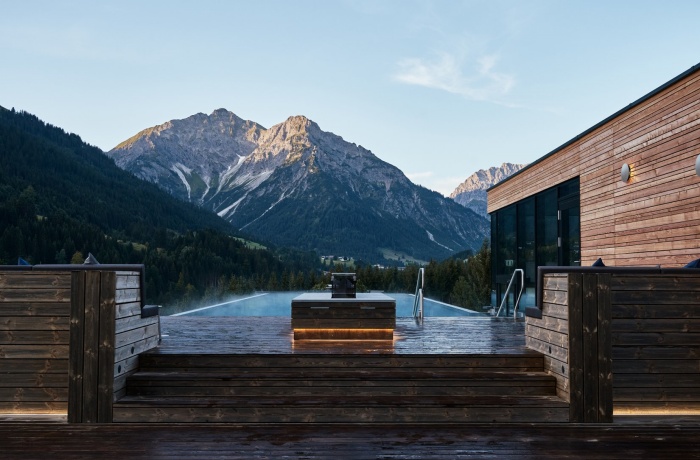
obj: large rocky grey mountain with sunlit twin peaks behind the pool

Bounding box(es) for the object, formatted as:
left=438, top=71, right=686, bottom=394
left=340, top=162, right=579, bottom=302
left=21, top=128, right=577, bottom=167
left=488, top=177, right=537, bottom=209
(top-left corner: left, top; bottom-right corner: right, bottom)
left=108, top=109, right=489, bottom=261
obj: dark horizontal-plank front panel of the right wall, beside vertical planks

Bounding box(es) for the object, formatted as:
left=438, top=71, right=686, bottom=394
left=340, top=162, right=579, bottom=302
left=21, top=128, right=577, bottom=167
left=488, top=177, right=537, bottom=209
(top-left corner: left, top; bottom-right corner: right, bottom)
left=611, top=274, right=700, bottom=414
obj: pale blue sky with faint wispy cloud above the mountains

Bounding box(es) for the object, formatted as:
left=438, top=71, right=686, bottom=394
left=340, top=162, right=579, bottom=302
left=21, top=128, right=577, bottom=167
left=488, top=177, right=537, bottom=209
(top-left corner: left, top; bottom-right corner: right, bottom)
left=0, top=0, right=700, bottom=195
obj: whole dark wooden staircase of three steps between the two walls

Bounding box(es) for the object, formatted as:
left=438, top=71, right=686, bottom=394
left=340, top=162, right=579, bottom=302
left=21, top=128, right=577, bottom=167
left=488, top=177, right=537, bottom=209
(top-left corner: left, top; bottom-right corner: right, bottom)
left=113, top=352, right=569, bottom=425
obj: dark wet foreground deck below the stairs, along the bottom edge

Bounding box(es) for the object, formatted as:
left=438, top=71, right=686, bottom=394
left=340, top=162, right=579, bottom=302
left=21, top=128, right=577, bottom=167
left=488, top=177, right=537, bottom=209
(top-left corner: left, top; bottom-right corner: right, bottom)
left=0, top=423, right=700, bottom=460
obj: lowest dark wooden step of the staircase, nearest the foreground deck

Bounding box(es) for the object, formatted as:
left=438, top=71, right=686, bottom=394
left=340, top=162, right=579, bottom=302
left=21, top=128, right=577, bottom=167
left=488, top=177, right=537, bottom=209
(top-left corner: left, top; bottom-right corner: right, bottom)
left=113, top=396, right=569, bottom=424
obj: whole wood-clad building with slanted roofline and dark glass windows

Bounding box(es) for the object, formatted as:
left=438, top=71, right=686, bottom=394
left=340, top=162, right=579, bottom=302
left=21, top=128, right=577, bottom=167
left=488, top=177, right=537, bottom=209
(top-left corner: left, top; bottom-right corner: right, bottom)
left=488, top=64, right=700, bottom=306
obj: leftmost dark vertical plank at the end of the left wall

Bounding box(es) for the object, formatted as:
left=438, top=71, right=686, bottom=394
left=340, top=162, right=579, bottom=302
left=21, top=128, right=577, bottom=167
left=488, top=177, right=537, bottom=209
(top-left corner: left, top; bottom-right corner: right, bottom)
left=68, top=271, right=86, bottom=423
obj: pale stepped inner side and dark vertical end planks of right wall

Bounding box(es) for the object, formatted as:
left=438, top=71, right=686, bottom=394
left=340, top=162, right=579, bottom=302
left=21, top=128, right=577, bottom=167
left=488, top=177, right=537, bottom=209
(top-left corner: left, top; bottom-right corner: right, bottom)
left=525, top=273, right=613, bottom=423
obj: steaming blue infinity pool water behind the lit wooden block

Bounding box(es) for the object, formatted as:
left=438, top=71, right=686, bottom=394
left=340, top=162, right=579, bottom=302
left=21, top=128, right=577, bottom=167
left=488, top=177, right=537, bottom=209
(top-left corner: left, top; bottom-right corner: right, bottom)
left=172, top=292, right=483, bottom=317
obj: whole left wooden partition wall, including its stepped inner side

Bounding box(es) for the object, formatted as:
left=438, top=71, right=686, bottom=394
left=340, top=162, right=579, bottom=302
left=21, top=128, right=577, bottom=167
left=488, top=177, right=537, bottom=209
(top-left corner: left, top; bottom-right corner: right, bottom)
left=0, top=265, right=159, bottom=423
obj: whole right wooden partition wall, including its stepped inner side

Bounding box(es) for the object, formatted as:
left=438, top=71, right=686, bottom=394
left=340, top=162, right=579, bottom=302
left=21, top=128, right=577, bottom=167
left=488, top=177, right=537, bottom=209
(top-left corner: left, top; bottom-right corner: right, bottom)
left=526, top=267, right=700, bottom=422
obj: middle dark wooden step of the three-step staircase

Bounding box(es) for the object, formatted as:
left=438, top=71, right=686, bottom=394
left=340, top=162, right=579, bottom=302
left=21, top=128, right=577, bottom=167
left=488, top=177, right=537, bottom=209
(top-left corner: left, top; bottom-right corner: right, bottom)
left=127, top=370, right=556, bottom=397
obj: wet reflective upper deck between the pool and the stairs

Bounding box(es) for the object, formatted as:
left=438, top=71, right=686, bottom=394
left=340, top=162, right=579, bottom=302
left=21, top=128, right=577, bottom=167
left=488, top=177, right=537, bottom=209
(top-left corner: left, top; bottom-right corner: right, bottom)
left=153, top=316, right=533, bottom=355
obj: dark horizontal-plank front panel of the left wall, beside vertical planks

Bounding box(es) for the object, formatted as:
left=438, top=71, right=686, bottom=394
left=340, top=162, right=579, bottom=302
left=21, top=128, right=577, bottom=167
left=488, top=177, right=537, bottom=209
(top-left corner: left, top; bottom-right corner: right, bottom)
left=0, top=271, right=71, bottom=414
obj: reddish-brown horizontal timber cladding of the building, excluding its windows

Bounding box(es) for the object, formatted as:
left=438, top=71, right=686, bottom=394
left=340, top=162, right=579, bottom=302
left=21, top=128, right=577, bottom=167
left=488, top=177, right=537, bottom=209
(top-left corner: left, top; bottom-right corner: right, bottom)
left=488, top=66, right=700, bottom=266
